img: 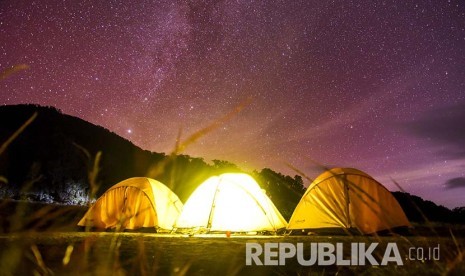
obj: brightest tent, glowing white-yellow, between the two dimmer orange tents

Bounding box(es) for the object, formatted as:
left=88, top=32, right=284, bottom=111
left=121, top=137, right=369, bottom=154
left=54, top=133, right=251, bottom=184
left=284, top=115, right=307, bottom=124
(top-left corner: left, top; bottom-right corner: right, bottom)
left=176, top=173, right=287, bottom=232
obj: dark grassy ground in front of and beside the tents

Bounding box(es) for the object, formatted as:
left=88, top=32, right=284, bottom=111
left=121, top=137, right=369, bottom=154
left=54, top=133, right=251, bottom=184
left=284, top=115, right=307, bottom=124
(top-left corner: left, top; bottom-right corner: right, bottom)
left=0, top=201, right=465, bottom=275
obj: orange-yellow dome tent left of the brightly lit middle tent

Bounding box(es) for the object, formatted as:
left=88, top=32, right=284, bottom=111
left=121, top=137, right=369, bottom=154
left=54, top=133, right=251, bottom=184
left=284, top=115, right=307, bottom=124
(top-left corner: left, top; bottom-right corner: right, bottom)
left=78, top=177, right=183, bottom=230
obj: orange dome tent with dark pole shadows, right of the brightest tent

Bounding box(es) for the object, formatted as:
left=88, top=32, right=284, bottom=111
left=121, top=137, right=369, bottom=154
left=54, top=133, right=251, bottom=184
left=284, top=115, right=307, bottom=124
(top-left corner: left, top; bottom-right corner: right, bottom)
left=288, top=168, right=410, bottom=234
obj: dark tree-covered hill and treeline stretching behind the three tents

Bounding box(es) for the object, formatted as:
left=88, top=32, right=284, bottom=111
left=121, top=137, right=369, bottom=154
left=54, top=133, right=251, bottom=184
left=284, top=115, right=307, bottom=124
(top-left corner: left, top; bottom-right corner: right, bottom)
left=0, top=105, right=465, bottom=223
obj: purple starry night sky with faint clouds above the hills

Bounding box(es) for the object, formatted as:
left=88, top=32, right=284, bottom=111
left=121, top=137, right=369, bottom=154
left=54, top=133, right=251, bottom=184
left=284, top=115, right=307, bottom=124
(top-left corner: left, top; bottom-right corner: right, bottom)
left=0, top=0, right=465, bottom=207
